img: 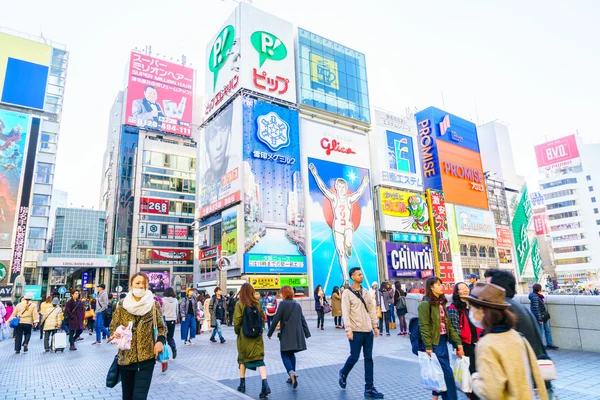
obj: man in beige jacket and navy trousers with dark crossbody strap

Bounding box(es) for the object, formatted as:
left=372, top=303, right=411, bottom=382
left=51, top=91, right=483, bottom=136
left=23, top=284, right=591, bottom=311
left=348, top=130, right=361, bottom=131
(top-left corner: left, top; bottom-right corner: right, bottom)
left=338, top=267, right=383, bottom=399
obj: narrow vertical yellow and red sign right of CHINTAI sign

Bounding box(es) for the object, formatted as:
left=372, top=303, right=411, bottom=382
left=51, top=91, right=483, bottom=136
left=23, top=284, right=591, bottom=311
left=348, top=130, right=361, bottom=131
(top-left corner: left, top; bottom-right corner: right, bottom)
left=427, top=189, right=454, bottom=294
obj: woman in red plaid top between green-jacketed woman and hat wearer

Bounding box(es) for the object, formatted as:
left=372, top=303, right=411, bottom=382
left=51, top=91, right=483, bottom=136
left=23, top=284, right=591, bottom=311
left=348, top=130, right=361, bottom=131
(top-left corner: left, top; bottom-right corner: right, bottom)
left=448, top=282, right=482, bottom=400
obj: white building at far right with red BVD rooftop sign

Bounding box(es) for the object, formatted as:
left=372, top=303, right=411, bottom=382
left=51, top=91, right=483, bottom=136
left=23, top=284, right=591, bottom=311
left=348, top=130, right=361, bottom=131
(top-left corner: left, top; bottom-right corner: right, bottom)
left=535, top=135, right=600, bottom=287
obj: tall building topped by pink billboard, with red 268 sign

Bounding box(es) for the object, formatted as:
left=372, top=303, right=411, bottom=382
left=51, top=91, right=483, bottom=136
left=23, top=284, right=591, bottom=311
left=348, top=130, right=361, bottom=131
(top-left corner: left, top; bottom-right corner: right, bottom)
left=99, top=51, right=201, bottom=292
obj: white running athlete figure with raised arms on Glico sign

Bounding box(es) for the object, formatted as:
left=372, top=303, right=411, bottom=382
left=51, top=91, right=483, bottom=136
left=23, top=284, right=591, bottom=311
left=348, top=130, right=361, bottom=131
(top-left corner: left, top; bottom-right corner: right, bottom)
left=308, top=163, right=369, bottom=284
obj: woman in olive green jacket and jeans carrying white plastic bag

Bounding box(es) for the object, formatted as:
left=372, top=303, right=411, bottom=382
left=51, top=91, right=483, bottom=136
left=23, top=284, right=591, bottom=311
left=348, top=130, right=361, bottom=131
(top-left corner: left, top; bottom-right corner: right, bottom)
left=418, top=276, right=464, bottom=400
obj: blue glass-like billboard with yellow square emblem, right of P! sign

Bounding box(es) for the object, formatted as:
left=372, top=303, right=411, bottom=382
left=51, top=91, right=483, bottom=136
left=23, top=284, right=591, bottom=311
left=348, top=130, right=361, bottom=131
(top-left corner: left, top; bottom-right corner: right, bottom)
left=298, top=28, right=371, bottom=124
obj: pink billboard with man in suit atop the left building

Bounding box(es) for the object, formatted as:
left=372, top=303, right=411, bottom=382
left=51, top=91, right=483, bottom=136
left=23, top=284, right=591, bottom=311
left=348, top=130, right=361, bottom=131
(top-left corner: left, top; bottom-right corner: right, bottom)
left=125, top=51, right=194, bottom=137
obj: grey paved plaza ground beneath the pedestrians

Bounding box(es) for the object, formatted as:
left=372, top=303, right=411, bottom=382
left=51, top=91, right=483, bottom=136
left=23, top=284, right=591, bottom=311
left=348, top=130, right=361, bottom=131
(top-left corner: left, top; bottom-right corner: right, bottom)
left=0, top=318, right=600, bottom=400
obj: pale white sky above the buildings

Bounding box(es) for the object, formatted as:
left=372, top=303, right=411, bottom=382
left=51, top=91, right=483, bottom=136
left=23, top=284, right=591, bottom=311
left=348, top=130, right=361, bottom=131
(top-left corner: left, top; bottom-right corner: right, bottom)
left=0, top=0, right=600, bottom=208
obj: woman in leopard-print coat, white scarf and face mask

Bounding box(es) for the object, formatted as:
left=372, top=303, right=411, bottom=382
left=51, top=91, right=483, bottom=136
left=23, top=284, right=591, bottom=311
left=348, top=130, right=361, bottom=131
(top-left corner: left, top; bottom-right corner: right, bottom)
left=109, top=272, right=167, bottom=400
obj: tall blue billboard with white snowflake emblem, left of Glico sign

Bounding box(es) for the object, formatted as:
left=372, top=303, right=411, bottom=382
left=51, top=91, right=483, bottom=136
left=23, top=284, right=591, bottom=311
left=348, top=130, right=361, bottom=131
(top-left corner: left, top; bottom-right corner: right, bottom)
left=243, top=97, right=306, bottom=273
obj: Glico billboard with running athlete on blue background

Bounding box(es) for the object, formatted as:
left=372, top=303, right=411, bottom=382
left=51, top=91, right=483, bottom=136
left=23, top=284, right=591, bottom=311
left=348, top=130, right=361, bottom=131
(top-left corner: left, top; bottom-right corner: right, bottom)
left=300, top=119, right=379, bottom=296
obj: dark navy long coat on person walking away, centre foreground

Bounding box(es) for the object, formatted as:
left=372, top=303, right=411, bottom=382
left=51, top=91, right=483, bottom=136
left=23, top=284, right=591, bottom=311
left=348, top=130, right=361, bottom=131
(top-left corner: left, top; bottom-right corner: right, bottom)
left=267, top=300, right=310, bottom=351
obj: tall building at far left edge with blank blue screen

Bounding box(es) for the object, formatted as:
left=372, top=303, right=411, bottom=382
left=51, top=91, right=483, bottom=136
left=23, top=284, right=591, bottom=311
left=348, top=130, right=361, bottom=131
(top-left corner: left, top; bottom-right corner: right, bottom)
left=0, top=28, right=69, bottom=296
